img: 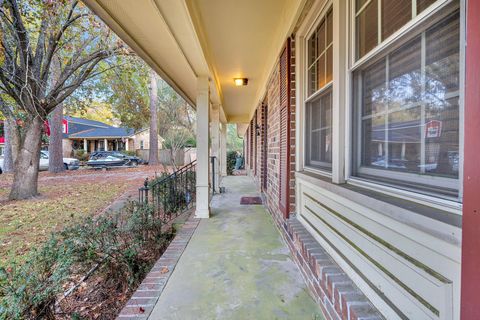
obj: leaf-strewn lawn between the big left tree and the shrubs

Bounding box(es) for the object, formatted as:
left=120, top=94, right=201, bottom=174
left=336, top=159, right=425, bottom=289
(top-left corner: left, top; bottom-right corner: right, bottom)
left=0, top=179, right=128, bottom=266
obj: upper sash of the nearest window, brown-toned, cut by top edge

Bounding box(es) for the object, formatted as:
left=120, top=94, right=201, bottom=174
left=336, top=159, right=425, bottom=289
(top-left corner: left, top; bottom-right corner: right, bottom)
left=355, top=0, right=437, bottom=59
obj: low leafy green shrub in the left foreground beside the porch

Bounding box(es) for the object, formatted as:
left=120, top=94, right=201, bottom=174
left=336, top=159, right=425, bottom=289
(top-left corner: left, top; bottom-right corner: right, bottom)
left=0, top=202, right=172, bottom=319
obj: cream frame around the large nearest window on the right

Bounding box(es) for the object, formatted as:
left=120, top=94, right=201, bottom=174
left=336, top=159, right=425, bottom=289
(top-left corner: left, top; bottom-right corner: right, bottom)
left=345, top=0, right=465, bottom=206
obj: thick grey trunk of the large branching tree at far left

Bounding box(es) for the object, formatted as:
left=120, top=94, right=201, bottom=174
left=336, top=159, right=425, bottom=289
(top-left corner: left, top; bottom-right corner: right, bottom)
left=9, top=117, right=43, bottom=200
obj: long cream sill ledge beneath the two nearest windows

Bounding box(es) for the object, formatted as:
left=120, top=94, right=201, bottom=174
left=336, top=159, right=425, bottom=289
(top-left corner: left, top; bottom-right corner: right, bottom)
left=296, top=171, right=462, bottom=246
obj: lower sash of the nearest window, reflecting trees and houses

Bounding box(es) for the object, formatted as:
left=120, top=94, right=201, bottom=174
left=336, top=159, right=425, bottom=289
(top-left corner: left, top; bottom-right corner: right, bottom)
left=353, top=1, right=461, bottom=197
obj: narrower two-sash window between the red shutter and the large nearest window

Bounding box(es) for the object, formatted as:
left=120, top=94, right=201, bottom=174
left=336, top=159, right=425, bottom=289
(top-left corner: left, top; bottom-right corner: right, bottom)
left=305, top=8, right=333, bottom=171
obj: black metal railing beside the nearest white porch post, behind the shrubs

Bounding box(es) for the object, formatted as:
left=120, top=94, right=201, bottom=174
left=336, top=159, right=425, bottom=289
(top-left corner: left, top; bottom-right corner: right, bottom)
left=138, top=161, right=197, bottom=222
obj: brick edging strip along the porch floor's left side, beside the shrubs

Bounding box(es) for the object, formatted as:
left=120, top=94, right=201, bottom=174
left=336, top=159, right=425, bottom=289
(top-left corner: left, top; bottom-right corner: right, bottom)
left=117, top=210, right=201, bottom=320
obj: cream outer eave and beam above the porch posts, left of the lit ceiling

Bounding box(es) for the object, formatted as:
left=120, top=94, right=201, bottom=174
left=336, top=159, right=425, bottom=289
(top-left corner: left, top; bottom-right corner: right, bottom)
left=84, top=0, right=219, bottom=106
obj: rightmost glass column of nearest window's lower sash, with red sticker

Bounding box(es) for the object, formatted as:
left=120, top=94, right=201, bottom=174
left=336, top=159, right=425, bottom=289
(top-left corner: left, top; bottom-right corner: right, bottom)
left=425, top=12, right=460, bottom=177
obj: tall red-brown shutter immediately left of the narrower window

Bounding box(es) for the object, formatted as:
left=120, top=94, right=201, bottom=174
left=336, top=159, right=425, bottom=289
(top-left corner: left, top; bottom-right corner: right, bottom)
left=279, top=39, right=290, bottom=219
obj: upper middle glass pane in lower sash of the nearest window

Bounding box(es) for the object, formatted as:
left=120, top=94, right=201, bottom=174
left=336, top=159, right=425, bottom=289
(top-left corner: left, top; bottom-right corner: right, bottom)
left=388, top=37, right=422, bottom=109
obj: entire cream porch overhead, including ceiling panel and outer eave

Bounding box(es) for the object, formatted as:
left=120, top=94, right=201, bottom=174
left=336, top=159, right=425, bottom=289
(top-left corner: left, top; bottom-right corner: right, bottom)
left=80, top=0, right=305, bottom=123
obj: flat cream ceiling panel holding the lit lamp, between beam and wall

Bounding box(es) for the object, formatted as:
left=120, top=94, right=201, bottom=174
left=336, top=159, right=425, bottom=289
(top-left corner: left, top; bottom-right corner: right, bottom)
left=186, top=0, right=304, bottom=123
